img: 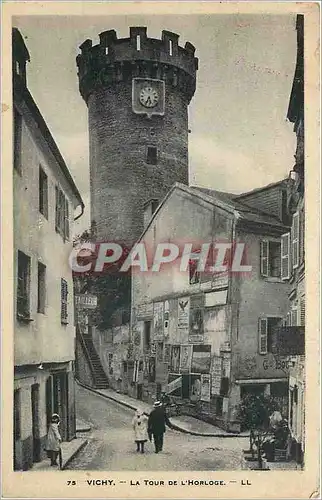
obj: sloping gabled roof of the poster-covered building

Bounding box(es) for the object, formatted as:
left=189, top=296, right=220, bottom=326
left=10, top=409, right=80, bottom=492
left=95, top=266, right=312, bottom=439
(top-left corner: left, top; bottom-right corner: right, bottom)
left=138, top=182, right=286, bottom=241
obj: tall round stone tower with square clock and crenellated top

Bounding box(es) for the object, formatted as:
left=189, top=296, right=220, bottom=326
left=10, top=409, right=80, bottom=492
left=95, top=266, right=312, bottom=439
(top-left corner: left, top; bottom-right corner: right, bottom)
left=77, top=27, right=198, bottom=244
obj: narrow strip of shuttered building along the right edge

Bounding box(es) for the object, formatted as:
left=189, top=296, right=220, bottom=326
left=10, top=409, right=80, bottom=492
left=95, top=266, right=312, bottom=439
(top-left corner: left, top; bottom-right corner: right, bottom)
left=277, top=15, right=306, bottom=463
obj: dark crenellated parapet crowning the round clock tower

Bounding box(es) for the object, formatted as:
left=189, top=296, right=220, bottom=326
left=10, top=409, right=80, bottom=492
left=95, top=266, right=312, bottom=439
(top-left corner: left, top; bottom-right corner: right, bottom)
left=76, top=27, right=198, bottom=103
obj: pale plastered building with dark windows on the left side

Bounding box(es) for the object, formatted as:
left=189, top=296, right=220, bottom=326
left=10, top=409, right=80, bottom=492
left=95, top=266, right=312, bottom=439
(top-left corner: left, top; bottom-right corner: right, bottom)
left=12, top=28, right=83, bottom=470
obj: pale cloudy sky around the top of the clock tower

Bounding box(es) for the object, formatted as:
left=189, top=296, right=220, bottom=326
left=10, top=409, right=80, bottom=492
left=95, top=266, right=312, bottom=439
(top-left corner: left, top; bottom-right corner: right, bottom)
left=13, top=14, right=296, bottom=233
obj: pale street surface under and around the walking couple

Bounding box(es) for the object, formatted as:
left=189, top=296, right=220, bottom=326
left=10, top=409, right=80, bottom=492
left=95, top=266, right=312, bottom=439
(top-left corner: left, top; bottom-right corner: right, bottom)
left=67, top=386, right=245, bottom=471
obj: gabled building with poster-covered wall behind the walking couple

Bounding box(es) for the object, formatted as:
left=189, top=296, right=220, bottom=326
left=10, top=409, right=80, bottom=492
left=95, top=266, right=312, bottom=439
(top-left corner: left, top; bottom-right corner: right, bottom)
left=97, top=180, right=289, bottom=430
